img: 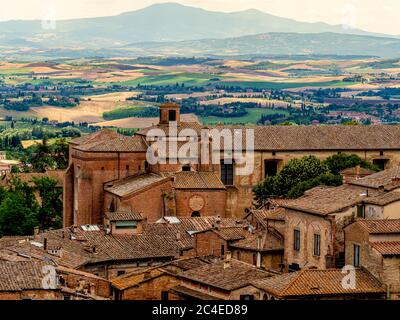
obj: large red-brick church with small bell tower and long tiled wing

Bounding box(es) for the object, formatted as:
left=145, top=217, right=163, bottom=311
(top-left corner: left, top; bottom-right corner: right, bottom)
left=64, top=103, right=400, bottom=227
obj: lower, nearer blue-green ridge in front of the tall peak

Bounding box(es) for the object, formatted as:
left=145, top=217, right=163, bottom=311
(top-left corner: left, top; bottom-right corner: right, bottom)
left=124, top=32, right=400, bottom=58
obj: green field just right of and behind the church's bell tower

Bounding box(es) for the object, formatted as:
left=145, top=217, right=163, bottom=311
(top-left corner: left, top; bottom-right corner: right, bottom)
left=200, top=108, right=289, bottom=125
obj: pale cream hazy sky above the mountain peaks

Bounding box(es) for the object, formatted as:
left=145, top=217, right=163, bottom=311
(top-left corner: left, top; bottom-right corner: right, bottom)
left=0, top=0, right=400, bottom=34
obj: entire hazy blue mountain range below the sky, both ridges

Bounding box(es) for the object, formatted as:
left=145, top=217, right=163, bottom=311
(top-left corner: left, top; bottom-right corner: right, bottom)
left=0, top=3, right=400, bottom=57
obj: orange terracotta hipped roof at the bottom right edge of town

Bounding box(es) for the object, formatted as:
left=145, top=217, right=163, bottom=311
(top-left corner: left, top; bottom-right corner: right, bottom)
left=252, top=269, right=385, bottom=298
